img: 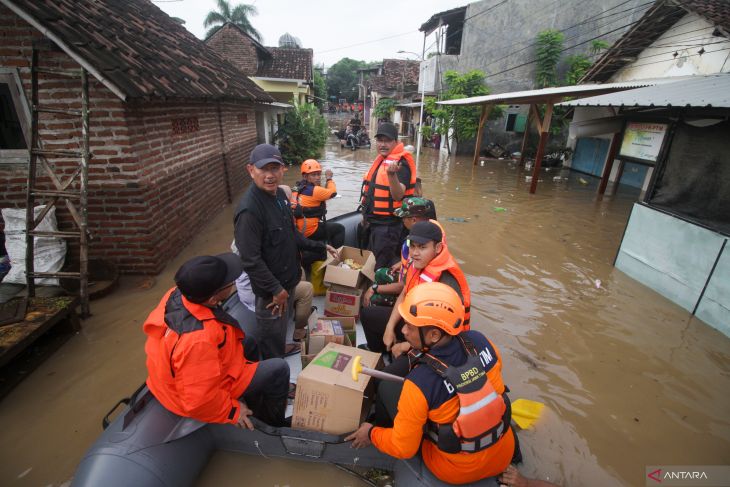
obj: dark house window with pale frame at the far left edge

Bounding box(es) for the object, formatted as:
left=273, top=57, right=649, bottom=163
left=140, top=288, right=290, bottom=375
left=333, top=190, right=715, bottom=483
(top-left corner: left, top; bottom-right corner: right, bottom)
left=0, top=70, right=30, bottom=164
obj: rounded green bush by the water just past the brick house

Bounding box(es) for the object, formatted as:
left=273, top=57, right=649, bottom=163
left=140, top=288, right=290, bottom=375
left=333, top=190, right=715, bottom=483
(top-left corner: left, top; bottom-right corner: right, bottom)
left=274, top=101, right=329, bottom=164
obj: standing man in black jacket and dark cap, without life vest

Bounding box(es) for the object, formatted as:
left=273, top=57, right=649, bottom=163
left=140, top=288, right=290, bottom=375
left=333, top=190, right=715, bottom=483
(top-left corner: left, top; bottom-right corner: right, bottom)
left=233, top=144, right=336, bottom=359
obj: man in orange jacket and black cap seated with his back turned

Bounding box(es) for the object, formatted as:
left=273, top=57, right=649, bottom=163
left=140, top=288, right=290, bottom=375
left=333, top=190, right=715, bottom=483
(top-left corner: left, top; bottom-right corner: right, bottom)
left=143, top=253, right=289, bottom=429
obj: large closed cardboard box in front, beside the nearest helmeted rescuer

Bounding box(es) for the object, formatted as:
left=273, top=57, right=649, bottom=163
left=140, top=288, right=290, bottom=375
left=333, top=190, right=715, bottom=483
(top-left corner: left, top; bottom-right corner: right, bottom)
left=292, top=343, right=380, bottom=435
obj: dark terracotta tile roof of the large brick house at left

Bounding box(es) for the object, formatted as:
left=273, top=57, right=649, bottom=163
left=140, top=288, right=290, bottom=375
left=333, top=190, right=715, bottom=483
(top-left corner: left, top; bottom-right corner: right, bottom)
left=4, top=0, right=274, bottom=102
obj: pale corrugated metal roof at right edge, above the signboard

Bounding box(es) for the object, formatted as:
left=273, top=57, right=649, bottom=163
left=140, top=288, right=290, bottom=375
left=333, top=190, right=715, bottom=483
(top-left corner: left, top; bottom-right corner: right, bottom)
left=560, top=73, right=730, bottom=108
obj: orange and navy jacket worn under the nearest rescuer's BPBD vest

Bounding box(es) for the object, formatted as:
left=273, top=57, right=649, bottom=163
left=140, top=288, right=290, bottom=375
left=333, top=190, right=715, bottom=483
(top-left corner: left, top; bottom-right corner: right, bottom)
left=370, top=331, right=515, bottom=484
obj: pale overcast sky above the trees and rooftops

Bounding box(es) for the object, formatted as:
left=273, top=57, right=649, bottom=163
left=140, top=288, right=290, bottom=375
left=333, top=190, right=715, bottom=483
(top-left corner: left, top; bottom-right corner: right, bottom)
left=153, top=0, right=468, bottom=67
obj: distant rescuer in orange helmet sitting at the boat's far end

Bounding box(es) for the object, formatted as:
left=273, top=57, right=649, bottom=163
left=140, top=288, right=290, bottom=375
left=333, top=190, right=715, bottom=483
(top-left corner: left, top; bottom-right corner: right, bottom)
left=291, top=159, right=345, bottom=248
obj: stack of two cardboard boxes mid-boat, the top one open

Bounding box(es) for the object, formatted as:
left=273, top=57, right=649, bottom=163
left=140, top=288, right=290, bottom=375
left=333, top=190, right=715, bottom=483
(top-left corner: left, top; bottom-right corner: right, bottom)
left=324, top=247, right=375, bottom=317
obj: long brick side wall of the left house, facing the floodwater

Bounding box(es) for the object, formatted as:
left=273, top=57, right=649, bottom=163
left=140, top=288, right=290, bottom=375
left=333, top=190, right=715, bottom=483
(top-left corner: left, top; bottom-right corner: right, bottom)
left=124, top=100, right=256, bottom=273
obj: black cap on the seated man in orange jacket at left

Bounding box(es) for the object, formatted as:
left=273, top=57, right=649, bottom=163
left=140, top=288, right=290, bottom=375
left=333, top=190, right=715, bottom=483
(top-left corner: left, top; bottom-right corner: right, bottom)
left=175, top=252, right=243, bottom=303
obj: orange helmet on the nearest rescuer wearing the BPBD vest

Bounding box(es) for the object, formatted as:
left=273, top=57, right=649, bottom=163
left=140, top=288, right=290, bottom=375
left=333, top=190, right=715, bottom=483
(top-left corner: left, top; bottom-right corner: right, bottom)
left=398, top=282, right=464, bottom=335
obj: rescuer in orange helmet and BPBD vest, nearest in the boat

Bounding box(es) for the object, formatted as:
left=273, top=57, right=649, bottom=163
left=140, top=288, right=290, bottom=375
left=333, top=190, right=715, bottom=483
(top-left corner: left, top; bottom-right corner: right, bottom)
left=345, top=282, right=515, bottom=485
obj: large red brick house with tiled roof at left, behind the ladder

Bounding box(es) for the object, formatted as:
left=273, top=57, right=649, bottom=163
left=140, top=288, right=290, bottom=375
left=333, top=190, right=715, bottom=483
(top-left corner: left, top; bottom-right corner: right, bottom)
left=0, top=0, right=274, bottom=274
